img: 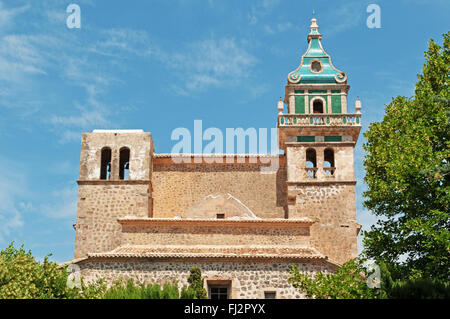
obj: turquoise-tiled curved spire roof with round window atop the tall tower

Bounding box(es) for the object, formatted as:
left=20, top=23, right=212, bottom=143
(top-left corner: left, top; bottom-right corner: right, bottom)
left=288, top=18, right=347, bottom=84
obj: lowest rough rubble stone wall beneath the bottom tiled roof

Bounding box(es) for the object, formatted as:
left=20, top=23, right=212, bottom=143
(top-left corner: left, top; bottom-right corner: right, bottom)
left=79, top=258, right=336, bottom=299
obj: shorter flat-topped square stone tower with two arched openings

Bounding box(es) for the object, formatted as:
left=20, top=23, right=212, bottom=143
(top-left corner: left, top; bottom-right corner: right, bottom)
left=75, top=130, right=153, bottom=258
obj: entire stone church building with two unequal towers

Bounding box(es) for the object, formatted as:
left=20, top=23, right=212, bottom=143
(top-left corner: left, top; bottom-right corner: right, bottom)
left=71, top=18, right=361, bottom=299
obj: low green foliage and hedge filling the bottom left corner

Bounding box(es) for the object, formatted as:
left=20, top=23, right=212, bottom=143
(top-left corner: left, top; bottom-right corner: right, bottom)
left=0, top=243, right=185, bottom=299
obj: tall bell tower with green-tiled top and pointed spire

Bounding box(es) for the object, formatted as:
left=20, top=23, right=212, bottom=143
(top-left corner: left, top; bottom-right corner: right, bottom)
left=277, top=18, right=361, bottom=263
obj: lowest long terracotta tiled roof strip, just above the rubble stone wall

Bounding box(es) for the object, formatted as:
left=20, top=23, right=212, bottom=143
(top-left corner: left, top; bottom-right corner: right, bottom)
left=88, top=245, right=327, bottom=260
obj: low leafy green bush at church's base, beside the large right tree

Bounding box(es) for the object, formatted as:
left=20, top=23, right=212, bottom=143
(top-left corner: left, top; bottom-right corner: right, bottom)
left=288, top=259, right=382, bottom=299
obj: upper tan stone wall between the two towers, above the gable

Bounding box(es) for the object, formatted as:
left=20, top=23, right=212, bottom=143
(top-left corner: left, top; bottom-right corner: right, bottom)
left=152, top=158, right=286, bottom=218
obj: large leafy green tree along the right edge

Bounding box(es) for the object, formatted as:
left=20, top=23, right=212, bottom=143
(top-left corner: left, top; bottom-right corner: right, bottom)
left=363, top=33, right=450, bottom=281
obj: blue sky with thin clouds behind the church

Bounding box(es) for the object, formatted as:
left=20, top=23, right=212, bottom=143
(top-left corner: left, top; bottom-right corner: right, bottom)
left=0, top=0, right=450, bottom=262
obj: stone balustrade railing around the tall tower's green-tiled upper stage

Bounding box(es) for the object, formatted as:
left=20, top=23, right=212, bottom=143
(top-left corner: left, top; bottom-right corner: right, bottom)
left=278, top=113, right=361, bottom=127
